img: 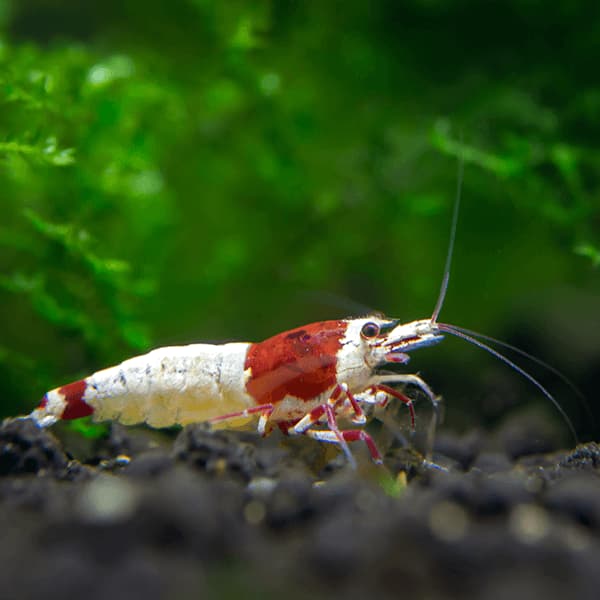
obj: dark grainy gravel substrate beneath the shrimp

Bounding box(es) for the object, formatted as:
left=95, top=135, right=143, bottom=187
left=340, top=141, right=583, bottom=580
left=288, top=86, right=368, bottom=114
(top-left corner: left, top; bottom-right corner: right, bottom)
left=0, top=420, right=600, bottom=600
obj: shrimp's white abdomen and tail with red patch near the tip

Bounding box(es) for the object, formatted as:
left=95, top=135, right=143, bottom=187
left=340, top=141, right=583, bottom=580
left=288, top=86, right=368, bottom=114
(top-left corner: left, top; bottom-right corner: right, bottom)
left=31, top=343, right=255, bottom=427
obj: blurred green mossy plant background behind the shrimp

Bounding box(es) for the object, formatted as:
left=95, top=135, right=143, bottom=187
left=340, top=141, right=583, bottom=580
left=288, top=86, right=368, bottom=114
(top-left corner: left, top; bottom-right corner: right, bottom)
left=0, top=0, right=600, bottom=437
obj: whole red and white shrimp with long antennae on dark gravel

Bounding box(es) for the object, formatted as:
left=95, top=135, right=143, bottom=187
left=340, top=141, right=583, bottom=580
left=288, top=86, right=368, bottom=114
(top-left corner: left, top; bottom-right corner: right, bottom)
left=28, top=165, right=574, bottom=464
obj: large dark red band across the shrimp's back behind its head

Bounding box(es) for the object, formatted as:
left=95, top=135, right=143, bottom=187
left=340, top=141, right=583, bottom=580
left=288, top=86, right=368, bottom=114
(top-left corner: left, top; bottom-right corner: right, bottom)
left=244, top=321, right=347, bottom=404
